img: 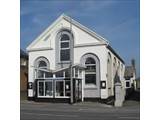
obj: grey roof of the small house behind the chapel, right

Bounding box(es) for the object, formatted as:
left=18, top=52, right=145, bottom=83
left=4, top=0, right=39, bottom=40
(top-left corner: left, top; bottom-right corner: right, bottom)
left=124, top=66, right=135, bottom=78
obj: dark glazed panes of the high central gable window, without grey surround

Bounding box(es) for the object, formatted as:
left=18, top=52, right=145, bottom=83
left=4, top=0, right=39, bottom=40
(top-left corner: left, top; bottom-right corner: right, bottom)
left=60, top=32, right=70, bottom=61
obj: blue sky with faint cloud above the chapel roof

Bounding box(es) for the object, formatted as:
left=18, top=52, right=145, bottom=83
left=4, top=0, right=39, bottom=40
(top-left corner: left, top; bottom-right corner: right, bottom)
left=20, top=0, right=140, bottom=77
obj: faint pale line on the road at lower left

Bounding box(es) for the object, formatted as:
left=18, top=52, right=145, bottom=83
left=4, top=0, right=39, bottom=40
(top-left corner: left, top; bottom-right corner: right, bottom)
left=22, top=112, right=78, bottom=117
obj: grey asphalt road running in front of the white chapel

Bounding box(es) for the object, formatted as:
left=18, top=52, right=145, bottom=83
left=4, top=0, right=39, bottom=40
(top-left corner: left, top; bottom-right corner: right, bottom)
left=20, top=101, right=140, bottom=120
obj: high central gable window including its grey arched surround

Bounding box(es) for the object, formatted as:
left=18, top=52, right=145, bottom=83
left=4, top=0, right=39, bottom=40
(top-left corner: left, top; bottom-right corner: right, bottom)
left=55, top=28, right=74, bottom=69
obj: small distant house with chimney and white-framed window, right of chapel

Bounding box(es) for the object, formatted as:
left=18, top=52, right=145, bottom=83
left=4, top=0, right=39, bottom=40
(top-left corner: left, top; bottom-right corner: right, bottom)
left=124, top=59, right=136, bottom=90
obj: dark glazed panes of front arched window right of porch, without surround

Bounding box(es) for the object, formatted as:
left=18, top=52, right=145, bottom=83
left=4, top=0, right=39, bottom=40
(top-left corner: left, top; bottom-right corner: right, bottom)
left=85, top=57, right=96, bottom=85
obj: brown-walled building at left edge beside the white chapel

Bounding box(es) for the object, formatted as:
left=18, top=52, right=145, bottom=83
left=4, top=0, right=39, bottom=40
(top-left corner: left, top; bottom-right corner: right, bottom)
left=20, top=49, right=28, bottom=92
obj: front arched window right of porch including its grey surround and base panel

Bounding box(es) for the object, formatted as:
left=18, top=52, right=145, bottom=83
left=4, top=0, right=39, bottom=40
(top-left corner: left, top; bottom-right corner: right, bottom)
left=80, top=53, right=101, bottom=97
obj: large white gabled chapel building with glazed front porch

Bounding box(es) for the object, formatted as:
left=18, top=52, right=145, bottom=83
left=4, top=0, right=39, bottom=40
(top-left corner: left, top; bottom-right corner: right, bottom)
left=27, top=14, right=125, bottom=102
